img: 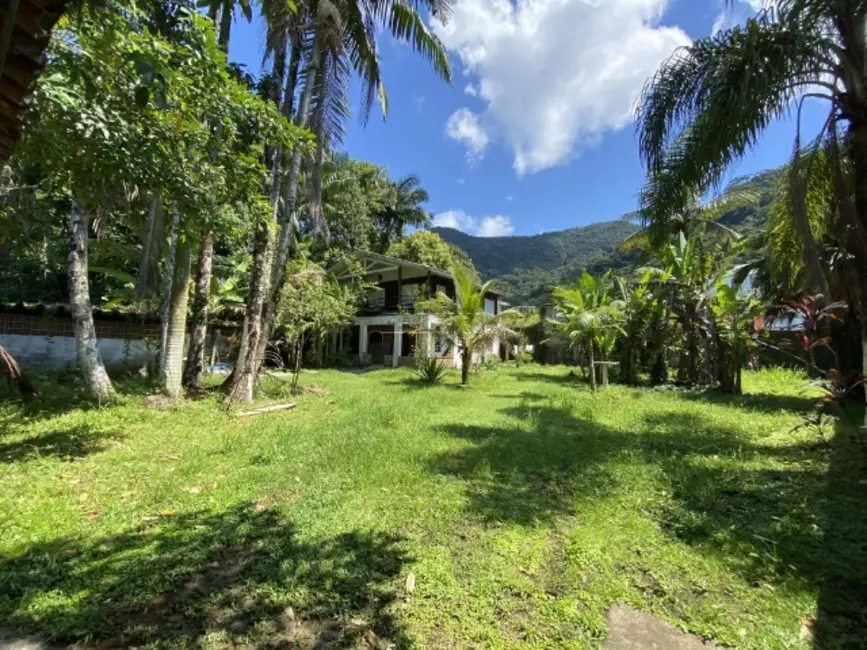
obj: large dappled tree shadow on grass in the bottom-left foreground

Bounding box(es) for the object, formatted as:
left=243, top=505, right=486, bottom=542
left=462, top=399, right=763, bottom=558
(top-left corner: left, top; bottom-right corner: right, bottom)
left=0, top=504, right=412, bottom=649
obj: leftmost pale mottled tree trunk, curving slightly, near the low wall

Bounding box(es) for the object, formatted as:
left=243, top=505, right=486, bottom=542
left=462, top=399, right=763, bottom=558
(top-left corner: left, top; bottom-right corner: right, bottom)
left=68, top=200, right=114, bottom=402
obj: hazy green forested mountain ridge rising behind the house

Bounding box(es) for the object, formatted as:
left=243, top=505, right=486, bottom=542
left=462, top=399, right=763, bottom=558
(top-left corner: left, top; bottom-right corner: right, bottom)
left=432, top=163, right=783, bottom=304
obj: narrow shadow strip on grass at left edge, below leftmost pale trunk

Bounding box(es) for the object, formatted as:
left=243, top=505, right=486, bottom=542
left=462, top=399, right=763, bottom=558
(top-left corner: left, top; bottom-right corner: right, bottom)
left=0, top=426, right=123, bottom=463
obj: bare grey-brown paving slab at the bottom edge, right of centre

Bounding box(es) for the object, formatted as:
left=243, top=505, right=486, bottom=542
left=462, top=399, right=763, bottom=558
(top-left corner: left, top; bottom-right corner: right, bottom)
left=605, top=605, right=719, bottom=650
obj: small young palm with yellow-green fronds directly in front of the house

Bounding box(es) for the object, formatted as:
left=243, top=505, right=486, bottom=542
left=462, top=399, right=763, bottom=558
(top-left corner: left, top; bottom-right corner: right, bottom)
left=418, top=266, right=515, bottom=386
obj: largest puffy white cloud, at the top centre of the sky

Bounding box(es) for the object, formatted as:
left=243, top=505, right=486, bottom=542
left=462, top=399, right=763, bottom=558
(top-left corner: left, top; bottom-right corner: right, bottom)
left=434, top=0, right=689, bottom=174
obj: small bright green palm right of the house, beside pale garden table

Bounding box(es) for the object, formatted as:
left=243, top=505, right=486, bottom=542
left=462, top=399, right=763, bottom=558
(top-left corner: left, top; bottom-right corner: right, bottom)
left=553, top=270, right=623, bottom=391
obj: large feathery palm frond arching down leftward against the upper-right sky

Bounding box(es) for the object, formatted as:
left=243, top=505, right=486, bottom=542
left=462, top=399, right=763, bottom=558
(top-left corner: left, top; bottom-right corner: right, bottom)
left=637, top=11, right=835, bottom=240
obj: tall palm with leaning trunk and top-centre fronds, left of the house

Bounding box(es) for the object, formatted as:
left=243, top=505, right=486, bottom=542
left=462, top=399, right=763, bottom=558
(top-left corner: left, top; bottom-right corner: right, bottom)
left=227, top=0, right=451, bottom=401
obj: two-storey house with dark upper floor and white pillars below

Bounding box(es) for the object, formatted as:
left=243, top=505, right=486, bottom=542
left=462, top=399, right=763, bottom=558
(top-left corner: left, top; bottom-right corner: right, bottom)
left=330, top=251, right=508, bottom=368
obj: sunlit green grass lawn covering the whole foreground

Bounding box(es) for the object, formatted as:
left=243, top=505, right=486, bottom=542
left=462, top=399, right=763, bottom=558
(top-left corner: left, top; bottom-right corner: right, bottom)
left=0, top=366, right=867, bottom=649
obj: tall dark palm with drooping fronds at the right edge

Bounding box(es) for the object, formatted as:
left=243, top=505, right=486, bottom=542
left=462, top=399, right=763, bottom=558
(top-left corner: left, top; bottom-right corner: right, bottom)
left=637, top=0, right=867, bottom=398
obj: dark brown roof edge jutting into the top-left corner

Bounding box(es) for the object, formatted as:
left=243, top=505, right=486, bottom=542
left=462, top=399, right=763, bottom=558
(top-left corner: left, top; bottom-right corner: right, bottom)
left=0, top=0, right=67, bottom=167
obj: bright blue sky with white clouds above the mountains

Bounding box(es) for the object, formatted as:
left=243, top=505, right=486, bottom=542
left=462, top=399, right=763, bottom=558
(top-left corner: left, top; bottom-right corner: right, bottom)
left=230, top=0, right=824, bottom=237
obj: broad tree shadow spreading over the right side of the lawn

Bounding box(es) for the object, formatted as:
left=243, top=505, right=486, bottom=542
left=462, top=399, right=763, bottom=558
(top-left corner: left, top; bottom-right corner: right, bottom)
left=430, top=400, right=867, bottom=650
